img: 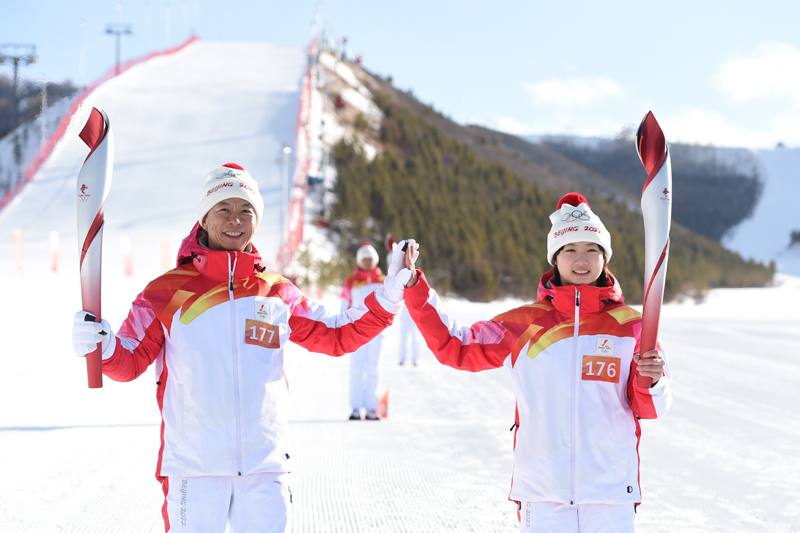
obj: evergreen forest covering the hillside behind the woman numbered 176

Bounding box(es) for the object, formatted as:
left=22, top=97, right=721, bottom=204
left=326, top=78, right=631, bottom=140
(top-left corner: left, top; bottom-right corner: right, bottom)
left=330, top=94, right=774, bottom=303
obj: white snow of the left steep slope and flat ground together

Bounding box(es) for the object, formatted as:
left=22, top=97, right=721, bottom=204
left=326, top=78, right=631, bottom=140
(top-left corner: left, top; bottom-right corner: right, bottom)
left=0, top=42, right=800, bottom=533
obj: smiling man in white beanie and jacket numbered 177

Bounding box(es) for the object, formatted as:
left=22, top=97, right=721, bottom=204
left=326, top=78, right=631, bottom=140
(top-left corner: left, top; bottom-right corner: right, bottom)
left=72, top=163, right=412, bottom=533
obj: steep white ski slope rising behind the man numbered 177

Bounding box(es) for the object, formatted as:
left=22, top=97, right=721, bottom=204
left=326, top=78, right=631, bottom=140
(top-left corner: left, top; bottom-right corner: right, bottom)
left=0, top=41, right=307, bottom=278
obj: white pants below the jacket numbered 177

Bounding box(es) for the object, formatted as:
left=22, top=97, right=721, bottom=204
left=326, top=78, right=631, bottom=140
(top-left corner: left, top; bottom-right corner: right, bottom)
left=161, top=472, right=292, bottom=533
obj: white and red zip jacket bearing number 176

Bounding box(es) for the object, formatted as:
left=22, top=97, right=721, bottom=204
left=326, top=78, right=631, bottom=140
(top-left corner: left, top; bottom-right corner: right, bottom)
left=405, top=270, right=672, bottom=504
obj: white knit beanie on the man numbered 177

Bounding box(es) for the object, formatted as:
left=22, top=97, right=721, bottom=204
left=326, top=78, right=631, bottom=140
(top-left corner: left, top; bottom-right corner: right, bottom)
left=197, top=163, right=264, bottom=227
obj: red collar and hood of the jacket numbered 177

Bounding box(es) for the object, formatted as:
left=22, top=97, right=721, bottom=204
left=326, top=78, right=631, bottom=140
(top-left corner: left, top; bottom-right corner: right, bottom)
left=178, top=223, right=262, bottom=281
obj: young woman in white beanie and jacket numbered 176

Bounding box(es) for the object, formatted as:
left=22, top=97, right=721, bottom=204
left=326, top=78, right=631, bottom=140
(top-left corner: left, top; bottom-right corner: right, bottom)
left=405, top=193, right=672, bottom=533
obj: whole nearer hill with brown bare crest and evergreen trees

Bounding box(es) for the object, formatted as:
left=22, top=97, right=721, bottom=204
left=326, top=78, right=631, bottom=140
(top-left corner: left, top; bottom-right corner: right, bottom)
left=320, top=57, right=775, bottom=302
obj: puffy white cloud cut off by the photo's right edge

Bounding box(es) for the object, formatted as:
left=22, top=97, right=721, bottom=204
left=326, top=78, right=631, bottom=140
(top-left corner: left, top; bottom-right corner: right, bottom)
left=715, top=42, right=800, bottom=105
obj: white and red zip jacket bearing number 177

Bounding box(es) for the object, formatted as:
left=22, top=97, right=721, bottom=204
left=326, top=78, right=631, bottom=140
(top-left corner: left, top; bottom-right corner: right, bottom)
left=103, top=225, right=399, bottom=479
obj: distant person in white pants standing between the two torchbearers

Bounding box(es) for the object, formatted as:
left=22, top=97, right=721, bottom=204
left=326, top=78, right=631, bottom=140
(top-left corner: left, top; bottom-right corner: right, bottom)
left=342, top=242, right=386, bottom=420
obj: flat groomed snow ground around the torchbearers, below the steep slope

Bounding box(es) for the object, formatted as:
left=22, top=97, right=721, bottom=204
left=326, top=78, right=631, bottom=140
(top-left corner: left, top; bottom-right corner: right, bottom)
left=0, top=273, right=800, bottom=533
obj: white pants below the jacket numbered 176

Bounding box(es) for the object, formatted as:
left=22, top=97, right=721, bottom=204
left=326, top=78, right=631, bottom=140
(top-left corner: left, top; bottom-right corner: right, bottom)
left=519, top=502, right=636, bottom=533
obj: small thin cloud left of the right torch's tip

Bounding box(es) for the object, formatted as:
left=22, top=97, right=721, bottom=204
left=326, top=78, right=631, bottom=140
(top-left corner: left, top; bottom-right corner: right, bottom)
left=523, top=77, right=625, bottom=107
